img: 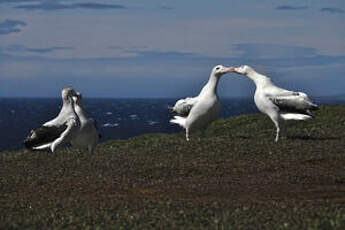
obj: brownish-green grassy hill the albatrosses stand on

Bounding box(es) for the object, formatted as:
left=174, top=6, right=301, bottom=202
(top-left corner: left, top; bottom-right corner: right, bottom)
left=0, top=105, right=345, bottom=229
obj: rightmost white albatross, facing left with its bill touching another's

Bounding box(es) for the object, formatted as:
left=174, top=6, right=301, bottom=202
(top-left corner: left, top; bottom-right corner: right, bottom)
left=234, top=65, right=318, bottom=142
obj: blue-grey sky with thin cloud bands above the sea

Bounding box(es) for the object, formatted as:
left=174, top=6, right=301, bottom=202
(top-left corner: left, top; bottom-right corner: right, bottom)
left=0, top=0, right=345, bottom=98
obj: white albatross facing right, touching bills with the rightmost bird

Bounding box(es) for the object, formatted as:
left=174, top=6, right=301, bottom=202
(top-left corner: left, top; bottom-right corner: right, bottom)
left=170, top=65, right=233, bottom=141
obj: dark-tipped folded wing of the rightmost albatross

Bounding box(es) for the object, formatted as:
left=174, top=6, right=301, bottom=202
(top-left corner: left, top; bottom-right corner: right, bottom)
left=269, top=92, right=318, bottom=116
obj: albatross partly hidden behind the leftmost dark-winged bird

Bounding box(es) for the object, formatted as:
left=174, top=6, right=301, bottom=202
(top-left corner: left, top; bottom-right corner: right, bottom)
left=71, top=93, right=99, bottom=153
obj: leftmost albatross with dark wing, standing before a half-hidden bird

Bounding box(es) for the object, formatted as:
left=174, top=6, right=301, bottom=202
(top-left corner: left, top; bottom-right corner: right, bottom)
left=24, top=88, right=80, bottom=153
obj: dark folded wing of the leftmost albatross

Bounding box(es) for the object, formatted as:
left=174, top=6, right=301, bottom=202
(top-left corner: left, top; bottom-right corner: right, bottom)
left=24, top=124, right=67, bottom=150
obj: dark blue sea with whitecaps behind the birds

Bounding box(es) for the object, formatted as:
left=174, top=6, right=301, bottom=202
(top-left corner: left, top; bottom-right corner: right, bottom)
left=0, top=96, right=345, bottom=151
